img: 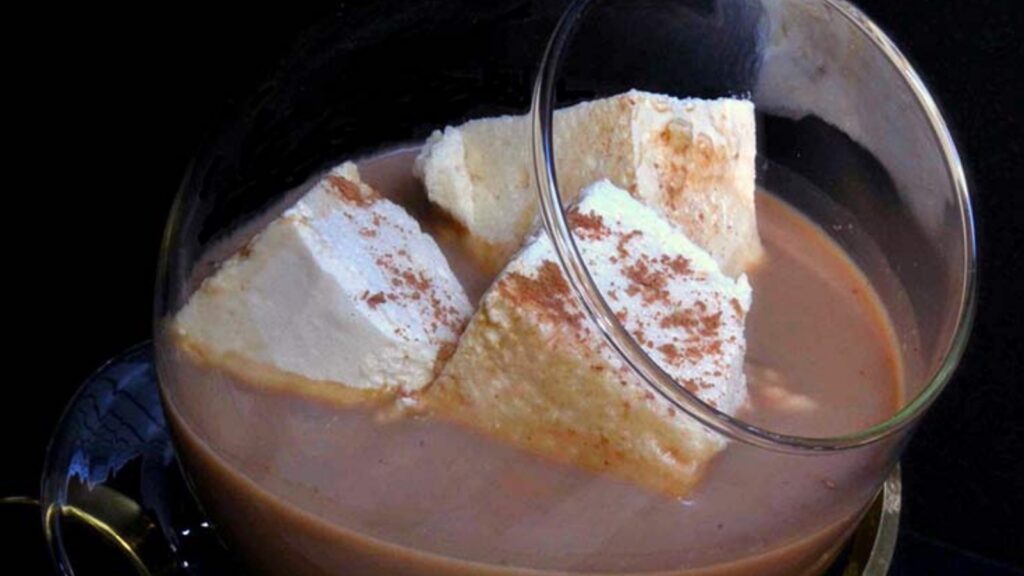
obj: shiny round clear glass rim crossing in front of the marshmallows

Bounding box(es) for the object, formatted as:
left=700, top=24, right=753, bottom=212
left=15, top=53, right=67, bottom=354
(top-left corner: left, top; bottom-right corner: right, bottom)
left=530, top=0, right=977, bottom=454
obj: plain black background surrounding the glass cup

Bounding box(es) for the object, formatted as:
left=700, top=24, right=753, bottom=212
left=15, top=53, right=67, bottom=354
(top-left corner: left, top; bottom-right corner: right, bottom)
left=0, top=0, right=1024, bottom=575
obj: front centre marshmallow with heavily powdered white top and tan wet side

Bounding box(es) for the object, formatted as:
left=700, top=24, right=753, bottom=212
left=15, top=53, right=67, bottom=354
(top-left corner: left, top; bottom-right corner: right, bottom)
left=422, top=181, right=751, bottom=496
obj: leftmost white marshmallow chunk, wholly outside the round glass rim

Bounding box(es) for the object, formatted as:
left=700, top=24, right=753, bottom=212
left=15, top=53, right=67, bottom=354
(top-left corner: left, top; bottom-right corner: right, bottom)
left=173, top=163, right=472, bottom=393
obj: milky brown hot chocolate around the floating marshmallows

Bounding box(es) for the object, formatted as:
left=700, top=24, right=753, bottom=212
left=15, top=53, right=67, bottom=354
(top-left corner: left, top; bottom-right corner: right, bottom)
left=162, top=148, right=902, bottom=575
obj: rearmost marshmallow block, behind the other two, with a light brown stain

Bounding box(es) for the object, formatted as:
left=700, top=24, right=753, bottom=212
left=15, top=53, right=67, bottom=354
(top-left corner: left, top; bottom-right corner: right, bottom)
left=415, top=90, right=763, bottom=276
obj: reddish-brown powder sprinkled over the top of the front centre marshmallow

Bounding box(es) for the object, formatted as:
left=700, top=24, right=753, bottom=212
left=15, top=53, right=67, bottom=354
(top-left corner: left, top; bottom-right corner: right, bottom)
left=485, top=188, right=745, bottom=412
